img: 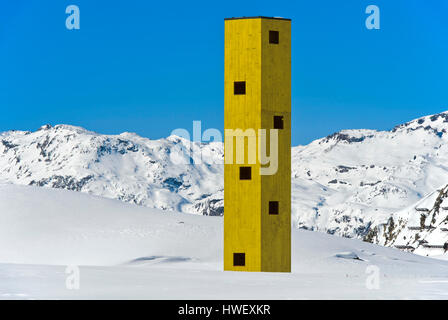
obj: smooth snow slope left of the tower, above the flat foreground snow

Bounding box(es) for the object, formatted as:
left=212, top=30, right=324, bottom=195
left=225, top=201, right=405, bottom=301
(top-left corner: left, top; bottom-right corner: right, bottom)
left=0, top=184, right=221, bottom=265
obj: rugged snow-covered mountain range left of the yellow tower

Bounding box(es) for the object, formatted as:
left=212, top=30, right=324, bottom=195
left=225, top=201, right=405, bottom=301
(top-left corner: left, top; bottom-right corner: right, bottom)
left=0, top=125, right=223, bottom=215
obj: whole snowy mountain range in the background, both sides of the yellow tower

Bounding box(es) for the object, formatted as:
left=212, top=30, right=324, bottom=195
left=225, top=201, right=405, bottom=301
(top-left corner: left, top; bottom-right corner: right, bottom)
left=0, top=112, right=448, bottom=239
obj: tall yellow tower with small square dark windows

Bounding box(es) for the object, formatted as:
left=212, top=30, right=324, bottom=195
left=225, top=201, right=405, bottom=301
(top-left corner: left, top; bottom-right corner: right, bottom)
left=224, top=17, right=291, bottom=272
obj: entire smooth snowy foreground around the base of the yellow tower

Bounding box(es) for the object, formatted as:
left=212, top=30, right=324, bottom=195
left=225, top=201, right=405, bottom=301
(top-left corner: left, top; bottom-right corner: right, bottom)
left=0, top=184, right=448, bottom=299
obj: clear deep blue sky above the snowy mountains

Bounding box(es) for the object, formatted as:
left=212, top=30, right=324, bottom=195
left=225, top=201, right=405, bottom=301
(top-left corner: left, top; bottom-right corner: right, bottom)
left=0, top=0, right=448, bottom=145
